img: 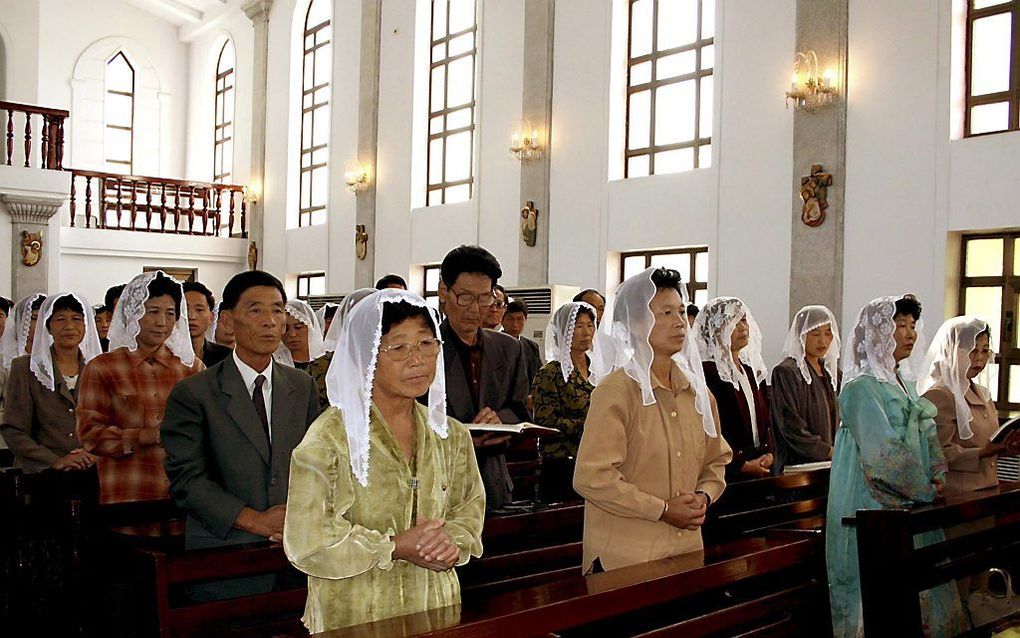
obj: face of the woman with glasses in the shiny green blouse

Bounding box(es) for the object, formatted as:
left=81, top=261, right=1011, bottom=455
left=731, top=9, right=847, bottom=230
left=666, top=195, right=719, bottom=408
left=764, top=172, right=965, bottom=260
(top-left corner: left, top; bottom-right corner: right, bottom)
left=372, top=316, right=441, bottom=399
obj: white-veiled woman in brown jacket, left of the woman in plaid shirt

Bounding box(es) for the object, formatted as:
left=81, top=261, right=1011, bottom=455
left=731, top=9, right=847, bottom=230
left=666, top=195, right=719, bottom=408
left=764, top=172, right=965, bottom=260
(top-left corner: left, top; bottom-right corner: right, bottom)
left=0, top=293, right=101, bottom=473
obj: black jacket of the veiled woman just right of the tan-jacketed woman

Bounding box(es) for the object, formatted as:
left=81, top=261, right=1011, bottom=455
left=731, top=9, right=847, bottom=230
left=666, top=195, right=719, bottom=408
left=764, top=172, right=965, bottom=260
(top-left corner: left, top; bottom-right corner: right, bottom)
left=702, top=361, right=772, bottom=480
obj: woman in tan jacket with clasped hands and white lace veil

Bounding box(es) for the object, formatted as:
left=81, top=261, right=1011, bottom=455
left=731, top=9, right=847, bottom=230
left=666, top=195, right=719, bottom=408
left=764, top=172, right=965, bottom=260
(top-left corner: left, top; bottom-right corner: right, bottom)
left=573, top=267, right=732, bottom=572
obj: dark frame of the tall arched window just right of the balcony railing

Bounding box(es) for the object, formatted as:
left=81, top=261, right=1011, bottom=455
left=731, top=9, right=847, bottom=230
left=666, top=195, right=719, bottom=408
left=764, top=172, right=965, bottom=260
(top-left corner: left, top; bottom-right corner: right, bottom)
left=298, top=0, right=334, bottom=228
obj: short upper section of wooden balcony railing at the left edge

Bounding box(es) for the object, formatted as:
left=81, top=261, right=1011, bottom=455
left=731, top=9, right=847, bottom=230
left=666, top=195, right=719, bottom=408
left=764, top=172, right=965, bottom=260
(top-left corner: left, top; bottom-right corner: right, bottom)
left=0, top=101, right=70, bottom=170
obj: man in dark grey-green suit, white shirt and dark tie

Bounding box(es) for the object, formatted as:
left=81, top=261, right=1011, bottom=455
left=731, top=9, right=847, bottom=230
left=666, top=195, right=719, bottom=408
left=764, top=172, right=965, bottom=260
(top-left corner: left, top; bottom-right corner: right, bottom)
left=161, top=271, right=319, bottom=549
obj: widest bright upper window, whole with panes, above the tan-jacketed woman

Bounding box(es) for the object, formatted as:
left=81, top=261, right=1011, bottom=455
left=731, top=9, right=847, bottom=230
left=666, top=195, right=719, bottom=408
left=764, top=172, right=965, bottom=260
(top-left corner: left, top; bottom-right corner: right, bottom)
left=624, top=0, right=715, bottom=178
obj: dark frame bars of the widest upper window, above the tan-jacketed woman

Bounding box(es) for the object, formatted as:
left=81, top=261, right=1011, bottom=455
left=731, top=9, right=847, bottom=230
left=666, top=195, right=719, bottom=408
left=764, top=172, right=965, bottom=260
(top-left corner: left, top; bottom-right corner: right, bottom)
left=623, top=0, right=715, bottom=179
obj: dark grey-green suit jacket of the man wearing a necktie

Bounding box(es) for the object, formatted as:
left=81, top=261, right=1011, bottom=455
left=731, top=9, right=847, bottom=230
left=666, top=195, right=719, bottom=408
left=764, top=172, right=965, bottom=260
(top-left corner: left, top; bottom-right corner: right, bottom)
left=160, top=356, right=319, bottom=548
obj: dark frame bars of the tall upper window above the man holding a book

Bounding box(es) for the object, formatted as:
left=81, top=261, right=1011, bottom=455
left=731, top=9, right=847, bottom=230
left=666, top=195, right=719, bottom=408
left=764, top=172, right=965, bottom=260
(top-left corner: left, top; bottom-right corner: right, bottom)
left=425, top=0, right=478, bottom=206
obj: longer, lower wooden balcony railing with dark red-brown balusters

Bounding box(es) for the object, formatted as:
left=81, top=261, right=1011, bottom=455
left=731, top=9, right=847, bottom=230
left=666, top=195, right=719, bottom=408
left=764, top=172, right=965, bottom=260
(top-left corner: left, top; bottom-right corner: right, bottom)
left=70, top=168, right=248, bottom=237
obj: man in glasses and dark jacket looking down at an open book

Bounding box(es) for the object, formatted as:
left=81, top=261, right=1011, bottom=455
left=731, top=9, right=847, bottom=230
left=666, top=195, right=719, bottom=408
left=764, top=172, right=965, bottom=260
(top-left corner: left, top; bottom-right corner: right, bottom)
left=439, top=245, right=530, bottom=509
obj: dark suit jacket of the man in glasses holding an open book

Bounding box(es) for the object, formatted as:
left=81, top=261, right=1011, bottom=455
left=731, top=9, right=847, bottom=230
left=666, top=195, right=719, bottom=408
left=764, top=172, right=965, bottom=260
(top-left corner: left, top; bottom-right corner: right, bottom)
left=440, top=321, right=531, bottom=507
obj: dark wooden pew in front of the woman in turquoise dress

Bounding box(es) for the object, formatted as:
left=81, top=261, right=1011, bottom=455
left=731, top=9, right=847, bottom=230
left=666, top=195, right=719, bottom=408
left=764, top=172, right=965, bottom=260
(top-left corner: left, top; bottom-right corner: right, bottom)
left=852, top=483, right=1020, bottom=636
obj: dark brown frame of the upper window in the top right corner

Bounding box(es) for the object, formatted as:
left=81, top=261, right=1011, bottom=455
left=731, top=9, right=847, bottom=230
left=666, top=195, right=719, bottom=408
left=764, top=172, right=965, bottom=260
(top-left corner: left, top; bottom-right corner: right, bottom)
left=963, top=0, right=1020, bottom=138
